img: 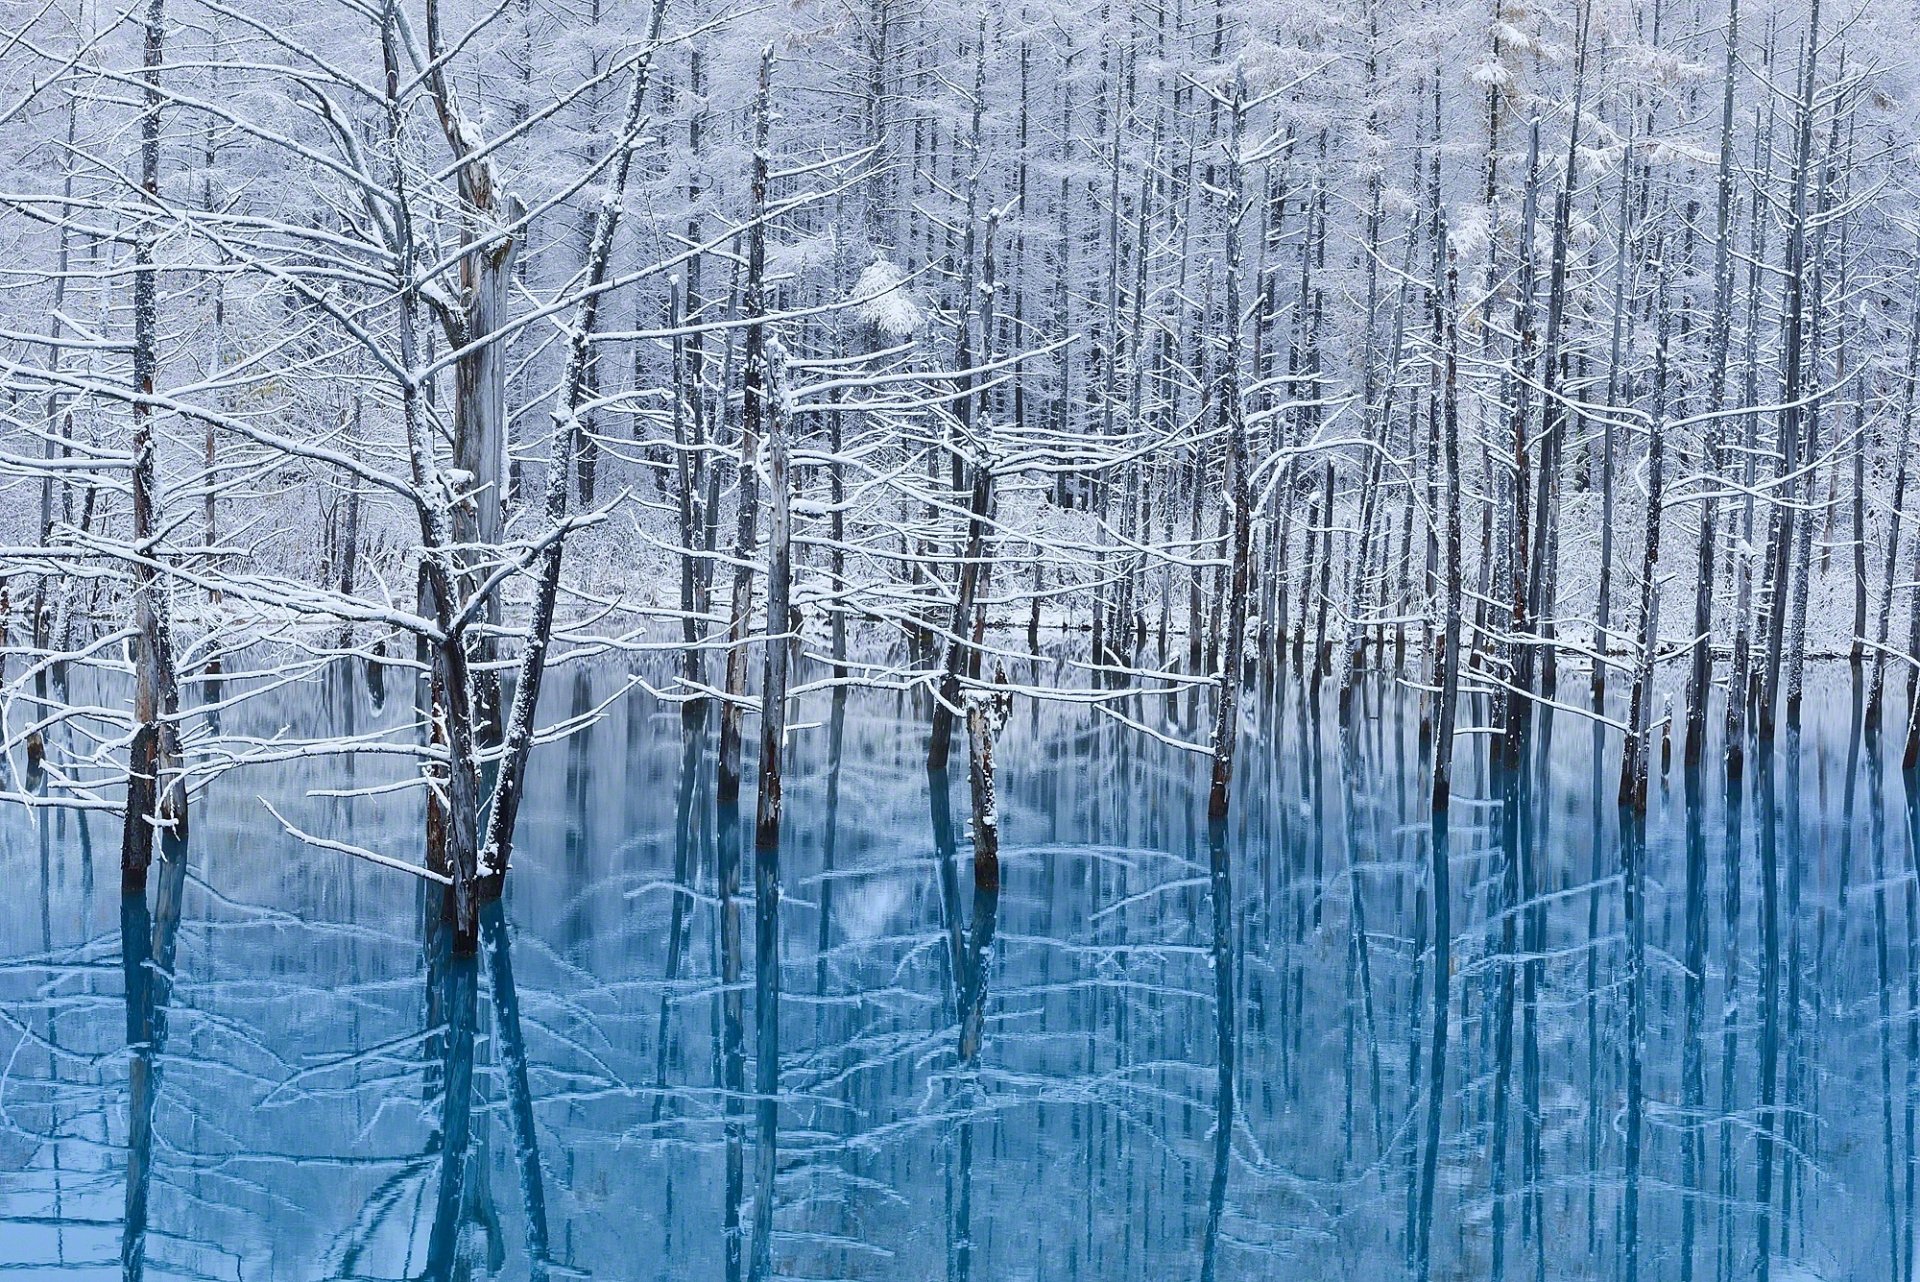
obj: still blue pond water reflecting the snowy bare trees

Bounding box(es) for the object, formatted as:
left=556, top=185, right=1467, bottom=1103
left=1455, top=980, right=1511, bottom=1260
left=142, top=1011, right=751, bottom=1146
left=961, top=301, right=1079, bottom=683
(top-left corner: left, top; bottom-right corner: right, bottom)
left=0, top=666, right=1920, bottom=1282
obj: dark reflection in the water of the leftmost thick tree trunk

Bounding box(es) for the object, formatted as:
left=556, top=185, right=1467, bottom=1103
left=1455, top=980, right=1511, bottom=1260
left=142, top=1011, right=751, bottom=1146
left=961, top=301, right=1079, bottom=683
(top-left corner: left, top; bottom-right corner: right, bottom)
left=121, top=835, right=186, bottom=1282
